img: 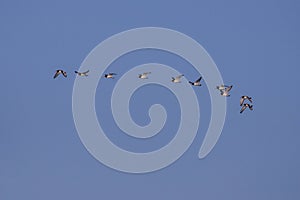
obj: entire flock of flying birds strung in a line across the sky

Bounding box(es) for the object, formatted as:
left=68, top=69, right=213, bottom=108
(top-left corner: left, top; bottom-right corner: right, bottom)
left=53, top=69, right=253, bottom=113
